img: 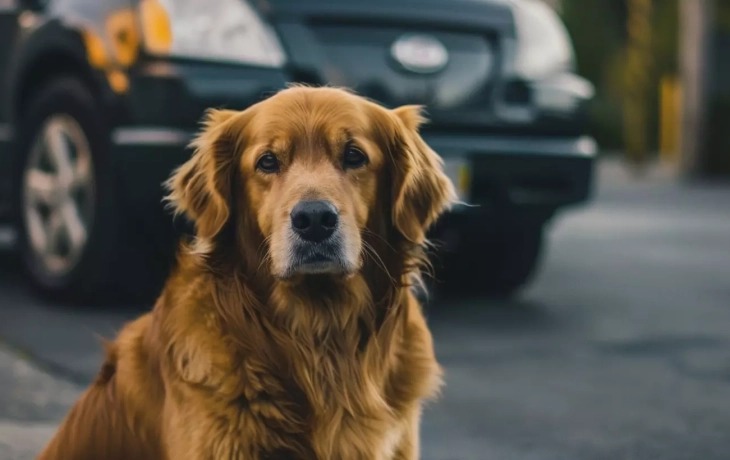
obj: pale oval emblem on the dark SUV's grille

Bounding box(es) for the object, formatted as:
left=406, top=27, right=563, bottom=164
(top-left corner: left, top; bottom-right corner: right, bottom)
left=390, top=34, right=449, bottom=74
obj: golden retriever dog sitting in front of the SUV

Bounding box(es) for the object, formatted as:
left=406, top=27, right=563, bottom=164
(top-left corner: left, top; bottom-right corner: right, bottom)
left=40, top=87, right=455, bottom=460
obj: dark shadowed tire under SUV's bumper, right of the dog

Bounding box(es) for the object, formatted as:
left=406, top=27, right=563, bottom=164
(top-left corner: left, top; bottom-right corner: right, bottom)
left=440, top=221, right=544, bottom=299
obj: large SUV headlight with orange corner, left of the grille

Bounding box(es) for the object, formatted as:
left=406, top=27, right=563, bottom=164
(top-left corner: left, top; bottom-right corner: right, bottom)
left=140, top=0, right=286, bottom=67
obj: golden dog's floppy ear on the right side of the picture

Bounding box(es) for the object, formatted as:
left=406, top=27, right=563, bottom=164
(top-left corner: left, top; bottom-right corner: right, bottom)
left=391, top=105, right=456, bottom=244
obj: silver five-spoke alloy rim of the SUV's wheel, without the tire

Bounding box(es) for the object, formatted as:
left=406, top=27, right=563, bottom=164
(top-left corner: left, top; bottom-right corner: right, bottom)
left=23, top=115, right=94, bottom=276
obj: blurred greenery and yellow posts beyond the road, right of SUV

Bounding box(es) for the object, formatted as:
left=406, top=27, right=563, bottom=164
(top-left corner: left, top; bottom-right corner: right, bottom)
left=551, top=0, right=730, bottom=176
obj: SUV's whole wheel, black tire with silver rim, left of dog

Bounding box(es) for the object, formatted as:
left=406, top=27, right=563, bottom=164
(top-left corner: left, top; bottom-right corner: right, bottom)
left=15, top=77, right=124, bottom=300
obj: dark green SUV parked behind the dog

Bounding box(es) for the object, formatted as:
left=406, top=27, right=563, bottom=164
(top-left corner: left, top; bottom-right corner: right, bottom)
left=0, top=0, right=596, bottom=296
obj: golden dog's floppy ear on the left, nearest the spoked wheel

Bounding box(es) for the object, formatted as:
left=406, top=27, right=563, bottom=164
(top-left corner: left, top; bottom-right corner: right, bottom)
left=165, top=110, right=241, bottom=240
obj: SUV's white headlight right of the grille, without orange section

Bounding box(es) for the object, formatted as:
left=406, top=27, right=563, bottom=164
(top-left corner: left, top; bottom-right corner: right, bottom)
left=513, top=0, right=574, bottom=80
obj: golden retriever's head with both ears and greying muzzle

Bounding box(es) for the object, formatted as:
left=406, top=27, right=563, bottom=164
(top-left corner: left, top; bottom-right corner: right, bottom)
left=167, top=87, right=455, bottom=280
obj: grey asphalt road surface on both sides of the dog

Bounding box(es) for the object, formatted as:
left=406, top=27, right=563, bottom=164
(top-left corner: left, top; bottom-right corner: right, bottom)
left=0, top=160, right=730, bottom=460
